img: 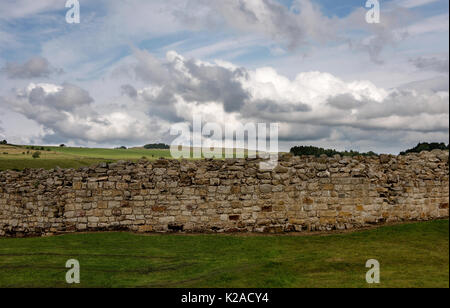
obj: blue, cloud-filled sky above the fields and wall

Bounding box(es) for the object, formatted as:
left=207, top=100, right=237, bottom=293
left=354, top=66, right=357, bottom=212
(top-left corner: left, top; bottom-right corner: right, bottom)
left=0, top=0, right=449, bottom=154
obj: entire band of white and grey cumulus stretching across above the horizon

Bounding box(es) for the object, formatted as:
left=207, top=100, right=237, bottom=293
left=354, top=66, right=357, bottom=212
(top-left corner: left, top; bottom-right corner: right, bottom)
left=3, top=50, right=449, bottom=149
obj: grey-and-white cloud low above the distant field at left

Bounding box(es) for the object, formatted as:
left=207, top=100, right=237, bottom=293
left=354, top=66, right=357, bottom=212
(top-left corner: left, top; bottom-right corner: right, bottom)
left=3, top=84, right=169, bottom=144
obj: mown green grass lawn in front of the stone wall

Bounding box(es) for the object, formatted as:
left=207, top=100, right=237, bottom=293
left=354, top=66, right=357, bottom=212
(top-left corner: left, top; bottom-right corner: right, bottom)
left=0, top=220, right=449, bottom=288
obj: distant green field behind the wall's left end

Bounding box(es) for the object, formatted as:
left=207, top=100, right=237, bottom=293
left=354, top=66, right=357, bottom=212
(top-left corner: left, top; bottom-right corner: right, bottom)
left=0, top=145, right=170, bottom=170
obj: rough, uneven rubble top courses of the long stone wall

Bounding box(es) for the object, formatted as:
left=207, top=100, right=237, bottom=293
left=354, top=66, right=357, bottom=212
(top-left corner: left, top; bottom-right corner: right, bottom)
left=0, top=150, right=449, bottom=180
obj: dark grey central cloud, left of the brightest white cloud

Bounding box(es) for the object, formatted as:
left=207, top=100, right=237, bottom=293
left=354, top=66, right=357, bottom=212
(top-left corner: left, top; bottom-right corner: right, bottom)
left=130, top=51, right=250, bottom=112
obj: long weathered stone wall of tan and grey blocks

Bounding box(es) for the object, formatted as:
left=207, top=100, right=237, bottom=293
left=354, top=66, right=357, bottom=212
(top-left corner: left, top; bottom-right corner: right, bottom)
left=0, top=151, right=449, bottom=236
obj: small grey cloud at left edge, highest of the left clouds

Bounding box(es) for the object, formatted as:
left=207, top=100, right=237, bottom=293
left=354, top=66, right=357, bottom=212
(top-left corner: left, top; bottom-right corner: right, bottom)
left=0, top=57, right=63, bottom=79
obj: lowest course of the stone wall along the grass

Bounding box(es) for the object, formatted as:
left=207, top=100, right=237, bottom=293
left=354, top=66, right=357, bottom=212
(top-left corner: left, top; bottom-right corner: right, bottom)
left=0, top=216, right=449, bottom=238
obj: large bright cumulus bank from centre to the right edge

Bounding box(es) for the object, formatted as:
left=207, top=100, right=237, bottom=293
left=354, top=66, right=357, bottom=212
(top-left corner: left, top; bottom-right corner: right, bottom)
left=118, top=52, right=449, bottom=147
